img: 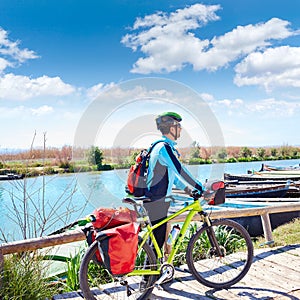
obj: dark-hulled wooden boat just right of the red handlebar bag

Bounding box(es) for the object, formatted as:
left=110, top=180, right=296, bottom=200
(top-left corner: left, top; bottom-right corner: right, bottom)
left=225, top=181, right=290, bottom=198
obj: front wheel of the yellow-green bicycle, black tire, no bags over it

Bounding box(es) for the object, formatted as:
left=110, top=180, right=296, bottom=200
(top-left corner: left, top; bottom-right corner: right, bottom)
left=186, top=219, right=253, bottom=289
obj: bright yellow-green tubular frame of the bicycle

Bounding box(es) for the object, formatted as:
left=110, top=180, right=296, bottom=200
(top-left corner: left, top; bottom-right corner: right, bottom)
left=128, top=200, right=207, bottom=276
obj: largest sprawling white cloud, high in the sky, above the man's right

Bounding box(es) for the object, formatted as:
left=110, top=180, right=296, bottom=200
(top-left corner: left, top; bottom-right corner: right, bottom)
left=121, top=4, right=297, bottom=74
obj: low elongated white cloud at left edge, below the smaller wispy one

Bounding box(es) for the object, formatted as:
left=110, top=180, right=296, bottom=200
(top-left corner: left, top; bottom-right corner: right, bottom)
left=0, top=73, right=75, bottom=100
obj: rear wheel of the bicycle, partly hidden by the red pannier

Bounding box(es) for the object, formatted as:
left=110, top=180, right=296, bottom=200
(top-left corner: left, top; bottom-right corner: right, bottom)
left=79, top=238, right=158, bottom=300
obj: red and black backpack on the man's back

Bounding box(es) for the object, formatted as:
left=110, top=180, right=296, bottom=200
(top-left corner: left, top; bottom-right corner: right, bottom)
left=126, top=141, right=164, bottom=197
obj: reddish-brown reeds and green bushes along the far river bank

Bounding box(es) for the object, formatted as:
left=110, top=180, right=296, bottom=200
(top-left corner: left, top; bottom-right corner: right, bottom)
left=0, top=142, right=300, bottom=176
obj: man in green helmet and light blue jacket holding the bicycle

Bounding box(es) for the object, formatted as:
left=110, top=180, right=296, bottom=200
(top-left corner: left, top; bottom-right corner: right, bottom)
left=144, top=112, right=204, bottom=252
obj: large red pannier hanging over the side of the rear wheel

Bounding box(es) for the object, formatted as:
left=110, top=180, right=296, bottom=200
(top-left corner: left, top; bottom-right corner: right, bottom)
left=96, top=223, right=139, bottom=275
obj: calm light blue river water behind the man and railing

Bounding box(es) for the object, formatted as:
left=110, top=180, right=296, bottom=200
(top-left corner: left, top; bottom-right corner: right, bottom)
left=0, top=160, right=299, bottom=240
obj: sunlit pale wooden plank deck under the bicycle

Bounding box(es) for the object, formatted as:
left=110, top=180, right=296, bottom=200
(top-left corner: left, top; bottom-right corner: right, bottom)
left=53, top=244, right=300, bottom=300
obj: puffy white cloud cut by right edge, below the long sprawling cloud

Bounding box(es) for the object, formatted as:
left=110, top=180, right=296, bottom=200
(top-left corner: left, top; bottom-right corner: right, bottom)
left=234, top=46, right=300, bottom=90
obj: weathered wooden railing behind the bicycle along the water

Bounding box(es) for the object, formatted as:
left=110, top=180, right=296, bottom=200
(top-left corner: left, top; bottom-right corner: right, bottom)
left=0, top=202, right=300, bottom=268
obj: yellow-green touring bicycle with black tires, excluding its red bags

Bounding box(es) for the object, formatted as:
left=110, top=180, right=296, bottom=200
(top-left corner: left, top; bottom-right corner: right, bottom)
left=79, top=182, right=253, bottom=300
